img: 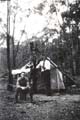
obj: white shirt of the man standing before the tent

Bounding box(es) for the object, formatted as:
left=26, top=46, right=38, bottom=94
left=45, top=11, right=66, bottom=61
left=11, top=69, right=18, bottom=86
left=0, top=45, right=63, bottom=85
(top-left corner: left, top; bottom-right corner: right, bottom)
left=37, top=60, right=50, bottom=72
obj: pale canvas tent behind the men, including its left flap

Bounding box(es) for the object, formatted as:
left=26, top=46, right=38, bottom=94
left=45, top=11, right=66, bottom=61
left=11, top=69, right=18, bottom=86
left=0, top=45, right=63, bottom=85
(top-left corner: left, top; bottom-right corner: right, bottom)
left=12, top=58, right=65, bottom=92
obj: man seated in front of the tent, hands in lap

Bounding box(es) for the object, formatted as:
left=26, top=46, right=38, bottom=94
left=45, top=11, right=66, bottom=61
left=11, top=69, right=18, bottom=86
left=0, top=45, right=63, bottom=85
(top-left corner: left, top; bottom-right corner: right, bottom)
left=15, top=72, right=33, bottom=102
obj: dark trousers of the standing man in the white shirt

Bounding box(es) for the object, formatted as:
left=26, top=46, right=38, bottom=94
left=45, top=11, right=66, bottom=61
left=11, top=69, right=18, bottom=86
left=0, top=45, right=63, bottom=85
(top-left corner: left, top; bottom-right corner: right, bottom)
left=41, top=70, right=51, bottom=95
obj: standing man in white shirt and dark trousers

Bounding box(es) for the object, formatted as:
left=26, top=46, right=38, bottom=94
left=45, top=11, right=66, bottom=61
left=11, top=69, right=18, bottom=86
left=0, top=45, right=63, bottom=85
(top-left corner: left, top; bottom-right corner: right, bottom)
left=37, top=56, right=51, bottom=95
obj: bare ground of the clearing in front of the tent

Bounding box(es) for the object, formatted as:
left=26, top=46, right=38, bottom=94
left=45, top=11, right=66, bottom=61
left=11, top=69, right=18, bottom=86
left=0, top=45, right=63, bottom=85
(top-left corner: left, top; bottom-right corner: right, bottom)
left=0, top=80, right=80, bottom=120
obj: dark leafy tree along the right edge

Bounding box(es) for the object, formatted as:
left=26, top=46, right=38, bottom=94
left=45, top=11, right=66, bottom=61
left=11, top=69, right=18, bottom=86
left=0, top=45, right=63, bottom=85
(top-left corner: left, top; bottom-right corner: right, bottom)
left=62, top=0, right=80, bottom=74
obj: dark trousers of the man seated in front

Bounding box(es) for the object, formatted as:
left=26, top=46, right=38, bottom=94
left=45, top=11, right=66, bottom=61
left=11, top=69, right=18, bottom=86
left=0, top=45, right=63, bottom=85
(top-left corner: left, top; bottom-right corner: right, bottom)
left=15, top=88, right=33, bottom=102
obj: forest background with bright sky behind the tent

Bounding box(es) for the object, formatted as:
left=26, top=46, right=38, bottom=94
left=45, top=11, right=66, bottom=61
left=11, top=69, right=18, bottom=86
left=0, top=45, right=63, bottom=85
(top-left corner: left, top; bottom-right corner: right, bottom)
left=0, top=0, right=80, bottom=75
